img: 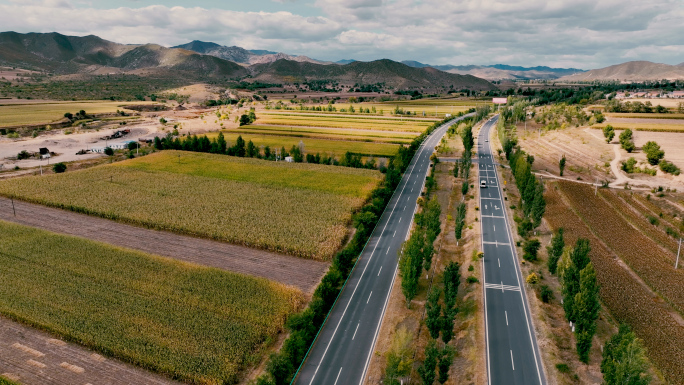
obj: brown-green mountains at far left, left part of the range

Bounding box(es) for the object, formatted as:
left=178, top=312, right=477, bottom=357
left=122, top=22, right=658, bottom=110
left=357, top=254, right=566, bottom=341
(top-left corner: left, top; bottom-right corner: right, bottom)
left=0, top=32, right=248, bottom=77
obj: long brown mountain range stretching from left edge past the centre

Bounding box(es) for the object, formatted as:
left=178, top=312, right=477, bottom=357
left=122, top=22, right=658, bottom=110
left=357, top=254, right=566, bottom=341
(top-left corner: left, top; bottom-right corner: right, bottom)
left=0, top=32, right=495, bottom=93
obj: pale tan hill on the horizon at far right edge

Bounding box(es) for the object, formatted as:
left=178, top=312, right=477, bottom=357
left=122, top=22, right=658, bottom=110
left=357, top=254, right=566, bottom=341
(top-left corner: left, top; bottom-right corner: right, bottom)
left=559, top=61, right=684, bottom=82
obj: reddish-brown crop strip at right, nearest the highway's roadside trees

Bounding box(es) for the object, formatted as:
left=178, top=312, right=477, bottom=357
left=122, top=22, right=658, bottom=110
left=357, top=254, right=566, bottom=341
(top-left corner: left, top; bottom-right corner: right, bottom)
left=544, top=184, right=684, bottom=383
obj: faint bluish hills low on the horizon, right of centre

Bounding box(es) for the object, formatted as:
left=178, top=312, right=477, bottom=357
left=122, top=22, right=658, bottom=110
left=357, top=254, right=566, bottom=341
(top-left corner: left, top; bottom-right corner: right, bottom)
left=402, top=60, right=582, bottom=80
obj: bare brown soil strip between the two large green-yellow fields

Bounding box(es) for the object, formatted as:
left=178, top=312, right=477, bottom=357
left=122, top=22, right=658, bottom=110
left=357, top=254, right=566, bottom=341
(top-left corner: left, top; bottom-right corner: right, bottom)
left=0, top=197, right=328, bottom=293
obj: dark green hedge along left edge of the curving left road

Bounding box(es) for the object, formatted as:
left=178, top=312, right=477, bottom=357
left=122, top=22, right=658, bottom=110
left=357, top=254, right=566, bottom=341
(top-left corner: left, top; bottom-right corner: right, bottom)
left=256, top=111, right=470, bottom=385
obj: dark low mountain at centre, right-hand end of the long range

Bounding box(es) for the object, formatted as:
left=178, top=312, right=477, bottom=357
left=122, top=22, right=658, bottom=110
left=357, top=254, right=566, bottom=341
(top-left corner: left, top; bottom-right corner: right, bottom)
left=250, top=59, right=495, bottom=91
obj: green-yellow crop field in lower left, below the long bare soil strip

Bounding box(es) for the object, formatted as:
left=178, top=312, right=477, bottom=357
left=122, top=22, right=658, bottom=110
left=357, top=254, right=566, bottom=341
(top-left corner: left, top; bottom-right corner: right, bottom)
left=0, top=221, right=303, bottom=384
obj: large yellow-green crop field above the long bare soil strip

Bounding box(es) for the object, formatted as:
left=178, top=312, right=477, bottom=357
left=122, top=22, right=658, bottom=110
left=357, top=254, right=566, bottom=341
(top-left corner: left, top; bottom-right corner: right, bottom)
left=0, top=150, right=382, bottom=260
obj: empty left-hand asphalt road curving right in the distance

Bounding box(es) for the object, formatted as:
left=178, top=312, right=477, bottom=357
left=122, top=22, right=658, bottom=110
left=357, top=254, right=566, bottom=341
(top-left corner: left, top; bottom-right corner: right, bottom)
left=296, top=114, right=472, bottom=385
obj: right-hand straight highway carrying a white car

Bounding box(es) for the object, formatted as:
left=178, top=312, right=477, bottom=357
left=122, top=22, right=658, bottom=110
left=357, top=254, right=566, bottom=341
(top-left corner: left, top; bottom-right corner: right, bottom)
left=478, top=116, right=546, bottom=385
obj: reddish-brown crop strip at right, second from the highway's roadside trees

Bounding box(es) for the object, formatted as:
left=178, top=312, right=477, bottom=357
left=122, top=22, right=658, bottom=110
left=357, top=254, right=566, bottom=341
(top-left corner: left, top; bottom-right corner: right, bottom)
left=559, top=183, right=684, bottom=311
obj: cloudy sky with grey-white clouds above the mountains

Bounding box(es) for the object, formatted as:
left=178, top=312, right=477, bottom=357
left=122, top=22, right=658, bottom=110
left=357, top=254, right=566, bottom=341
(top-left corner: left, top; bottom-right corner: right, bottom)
left=0, top=0, right=684, bottom=69
